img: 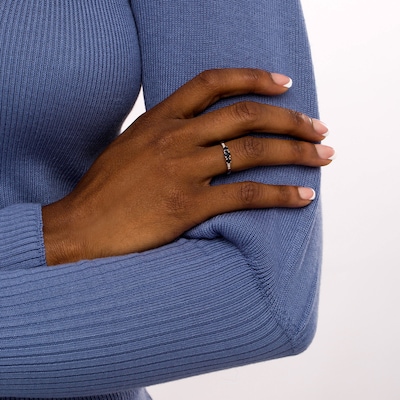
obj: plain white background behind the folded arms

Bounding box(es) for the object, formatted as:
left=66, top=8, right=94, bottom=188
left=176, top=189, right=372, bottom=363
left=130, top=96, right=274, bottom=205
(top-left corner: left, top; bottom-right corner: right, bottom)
left=122, top=0, right=400, bottom=400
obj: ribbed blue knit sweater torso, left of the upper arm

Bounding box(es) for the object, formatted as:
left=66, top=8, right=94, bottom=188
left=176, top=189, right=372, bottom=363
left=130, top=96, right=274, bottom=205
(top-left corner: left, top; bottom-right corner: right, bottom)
left=0, top=0, right=140, bottom=207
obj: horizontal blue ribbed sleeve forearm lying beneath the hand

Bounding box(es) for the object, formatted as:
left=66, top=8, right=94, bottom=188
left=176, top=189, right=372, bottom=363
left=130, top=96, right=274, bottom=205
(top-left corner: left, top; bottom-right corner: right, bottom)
left=0, top=231, right=315, bottom=397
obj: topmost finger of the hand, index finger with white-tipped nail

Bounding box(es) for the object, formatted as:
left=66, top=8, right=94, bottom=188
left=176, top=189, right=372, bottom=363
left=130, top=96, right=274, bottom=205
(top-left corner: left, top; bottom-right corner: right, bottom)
left=158, top=68, right=292, bottom=118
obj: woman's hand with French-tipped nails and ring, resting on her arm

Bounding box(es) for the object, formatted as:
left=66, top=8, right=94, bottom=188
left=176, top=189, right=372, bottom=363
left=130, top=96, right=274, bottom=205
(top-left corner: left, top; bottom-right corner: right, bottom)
left=43, top=69, right=334, bottom=265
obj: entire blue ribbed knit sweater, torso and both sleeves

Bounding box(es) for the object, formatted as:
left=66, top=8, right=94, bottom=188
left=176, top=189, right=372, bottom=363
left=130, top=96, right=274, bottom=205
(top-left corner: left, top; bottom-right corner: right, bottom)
left=0, top=0, right=321, bottom=400
